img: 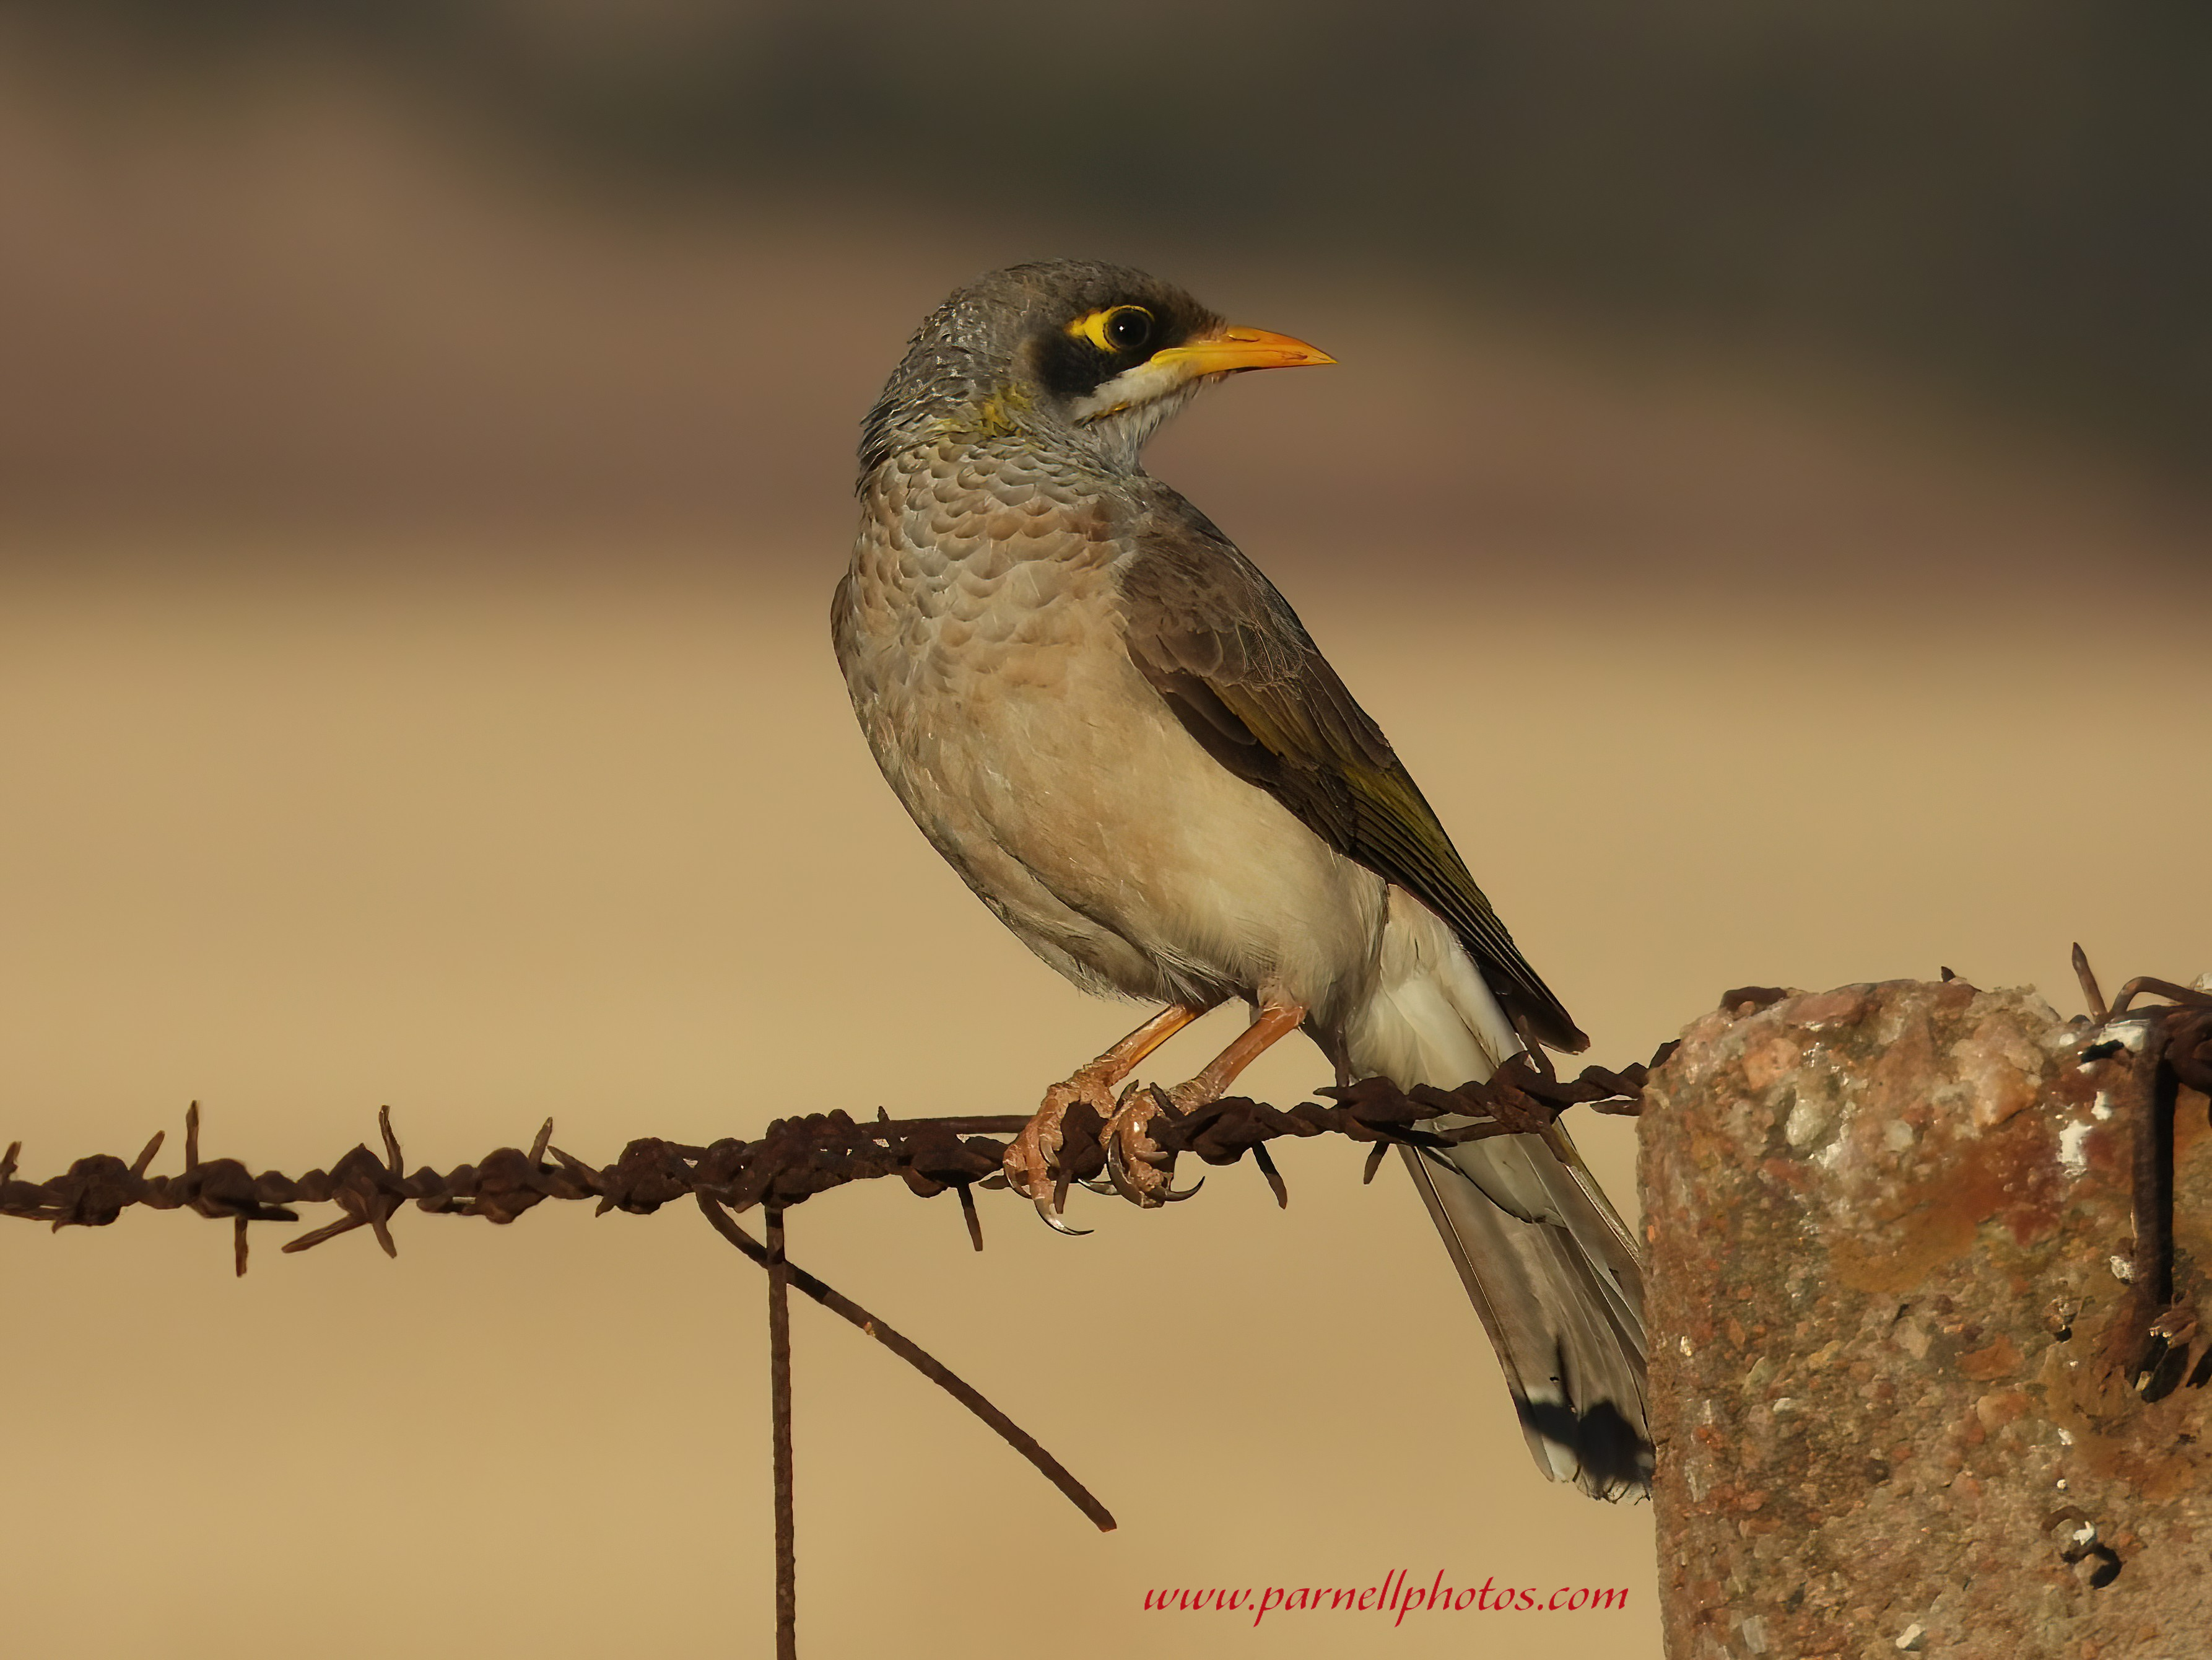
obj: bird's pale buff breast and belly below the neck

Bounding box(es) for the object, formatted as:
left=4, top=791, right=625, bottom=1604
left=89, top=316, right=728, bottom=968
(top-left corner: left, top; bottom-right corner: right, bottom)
left=838, top=546, right=1383, bottom=1027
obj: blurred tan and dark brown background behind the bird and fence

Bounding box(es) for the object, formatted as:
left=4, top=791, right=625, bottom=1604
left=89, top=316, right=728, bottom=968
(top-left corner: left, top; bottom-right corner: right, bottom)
left=0, top=0, right=2212, bottom=1658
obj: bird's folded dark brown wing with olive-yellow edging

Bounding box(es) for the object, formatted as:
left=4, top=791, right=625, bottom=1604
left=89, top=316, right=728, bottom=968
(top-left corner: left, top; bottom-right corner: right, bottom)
left=1119, top=500, right=1588, bottom=1051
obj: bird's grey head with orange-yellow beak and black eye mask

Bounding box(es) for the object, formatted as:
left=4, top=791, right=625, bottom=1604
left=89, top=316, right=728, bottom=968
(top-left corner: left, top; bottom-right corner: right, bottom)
left=861, top=259, right=1334, bottom=480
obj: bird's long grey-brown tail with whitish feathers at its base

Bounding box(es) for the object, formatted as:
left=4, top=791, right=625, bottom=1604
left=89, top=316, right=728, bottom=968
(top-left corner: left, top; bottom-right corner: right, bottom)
left=1345, top=888, right=1652, bottom=1498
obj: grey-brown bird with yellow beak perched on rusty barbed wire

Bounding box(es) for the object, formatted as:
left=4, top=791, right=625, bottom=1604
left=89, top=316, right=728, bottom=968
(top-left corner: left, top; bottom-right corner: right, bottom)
left=832, top=259, right=1652, bottom=1496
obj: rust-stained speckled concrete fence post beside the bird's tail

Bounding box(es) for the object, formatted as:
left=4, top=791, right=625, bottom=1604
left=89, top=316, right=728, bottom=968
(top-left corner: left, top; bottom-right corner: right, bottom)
left=1641, top=981, right=2212, bottom=1660
